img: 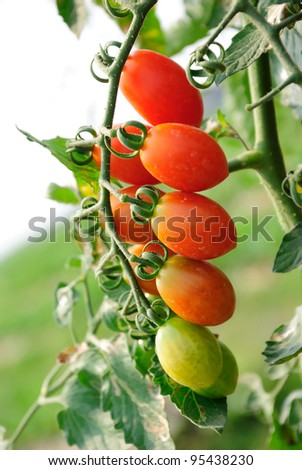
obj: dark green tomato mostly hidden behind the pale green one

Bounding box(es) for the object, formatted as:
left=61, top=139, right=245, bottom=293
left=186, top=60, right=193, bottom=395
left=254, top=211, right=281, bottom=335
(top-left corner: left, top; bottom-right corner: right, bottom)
left=195, top=341, right=238, bottom=398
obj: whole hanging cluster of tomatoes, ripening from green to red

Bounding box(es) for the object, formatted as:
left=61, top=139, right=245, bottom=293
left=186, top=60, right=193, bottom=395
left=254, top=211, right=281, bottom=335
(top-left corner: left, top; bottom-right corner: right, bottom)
left=93, top=50, right=238, bottom=398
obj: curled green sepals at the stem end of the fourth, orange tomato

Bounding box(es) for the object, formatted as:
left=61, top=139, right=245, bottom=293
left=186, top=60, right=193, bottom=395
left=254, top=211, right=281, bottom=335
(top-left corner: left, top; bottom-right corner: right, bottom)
left=130, top=240, right=168, bottom=281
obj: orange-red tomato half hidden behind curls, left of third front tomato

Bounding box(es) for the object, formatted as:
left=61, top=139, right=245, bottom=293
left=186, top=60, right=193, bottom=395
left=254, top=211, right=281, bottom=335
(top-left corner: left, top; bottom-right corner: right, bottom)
left=110, top=186, right=163, bottom=245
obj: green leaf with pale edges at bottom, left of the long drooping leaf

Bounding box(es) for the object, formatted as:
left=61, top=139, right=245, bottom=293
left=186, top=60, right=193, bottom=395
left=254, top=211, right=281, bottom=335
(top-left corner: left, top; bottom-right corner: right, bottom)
left=58, top=351, right=133, bottom=450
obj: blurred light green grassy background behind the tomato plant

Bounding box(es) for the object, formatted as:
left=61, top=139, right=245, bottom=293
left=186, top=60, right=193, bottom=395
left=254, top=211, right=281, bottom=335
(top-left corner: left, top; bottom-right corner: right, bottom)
left=0, top=85, right=302, bottom=449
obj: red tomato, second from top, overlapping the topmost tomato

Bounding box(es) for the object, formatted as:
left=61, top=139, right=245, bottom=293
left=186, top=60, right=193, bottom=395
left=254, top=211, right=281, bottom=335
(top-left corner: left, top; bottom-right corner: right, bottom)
left=140, top=123, right=229, bottom=192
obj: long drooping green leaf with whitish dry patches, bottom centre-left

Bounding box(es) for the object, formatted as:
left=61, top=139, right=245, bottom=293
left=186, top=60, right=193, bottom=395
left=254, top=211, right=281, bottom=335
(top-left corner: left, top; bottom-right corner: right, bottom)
left=98, top=335, right=174, bottom=450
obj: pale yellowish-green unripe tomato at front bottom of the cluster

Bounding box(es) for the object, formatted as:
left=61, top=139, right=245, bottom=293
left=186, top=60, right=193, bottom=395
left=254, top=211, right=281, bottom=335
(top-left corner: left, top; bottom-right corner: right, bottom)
left=155, top=316, right=222, bottom=390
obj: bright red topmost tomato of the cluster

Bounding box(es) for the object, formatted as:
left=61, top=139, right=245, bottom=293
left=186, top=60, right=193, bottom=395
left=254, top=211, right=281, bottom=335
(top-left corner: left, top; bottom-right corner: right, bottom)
left=120, top=49, right=203, bottom=127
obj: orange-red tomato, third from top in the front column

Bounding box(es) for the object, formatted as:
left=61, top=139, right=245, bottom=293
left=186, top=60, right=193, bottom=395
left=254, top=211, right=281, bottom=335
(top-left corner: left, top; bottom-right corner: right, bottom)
left=152, top=192, right=236, bottom=260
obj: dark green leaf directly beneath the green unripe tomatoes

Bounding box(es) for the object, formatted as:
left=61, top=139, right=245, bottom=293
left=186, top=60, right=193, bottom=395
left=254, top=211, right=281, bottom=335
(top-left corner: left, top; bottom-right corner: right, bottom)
left=149, top=356, right=227, bottom=433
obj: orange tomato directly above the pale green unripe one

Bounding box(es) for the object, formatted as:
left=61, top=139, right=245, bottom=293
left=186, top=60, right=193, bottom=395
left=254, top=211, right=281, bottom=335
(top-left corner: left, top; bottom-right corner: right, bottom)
left=156, top=255, right=236, bottom=326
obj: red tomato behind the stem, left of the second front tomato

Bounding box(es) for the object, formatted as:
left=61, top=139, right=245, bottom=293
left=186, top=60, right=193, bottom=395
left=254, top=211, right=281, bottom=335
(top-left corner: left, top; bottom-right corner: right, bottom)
left=92, top=124, right=158, bottom=185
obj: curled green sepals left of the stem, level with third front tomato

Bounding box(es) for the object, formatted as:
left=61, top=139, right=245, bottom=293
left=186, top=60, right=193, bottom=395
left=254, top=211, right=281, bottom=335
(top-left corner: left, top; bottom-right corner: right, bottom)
left=74, top=196, right=101, bottom=241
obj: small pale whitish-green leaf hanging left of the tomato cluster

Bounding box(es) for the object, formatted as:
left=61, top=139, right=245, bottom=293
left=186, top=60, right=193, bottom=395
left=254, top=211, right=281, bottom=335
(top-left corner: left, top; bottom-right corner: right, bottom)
left=54, top=282, right=80, bottom=326
